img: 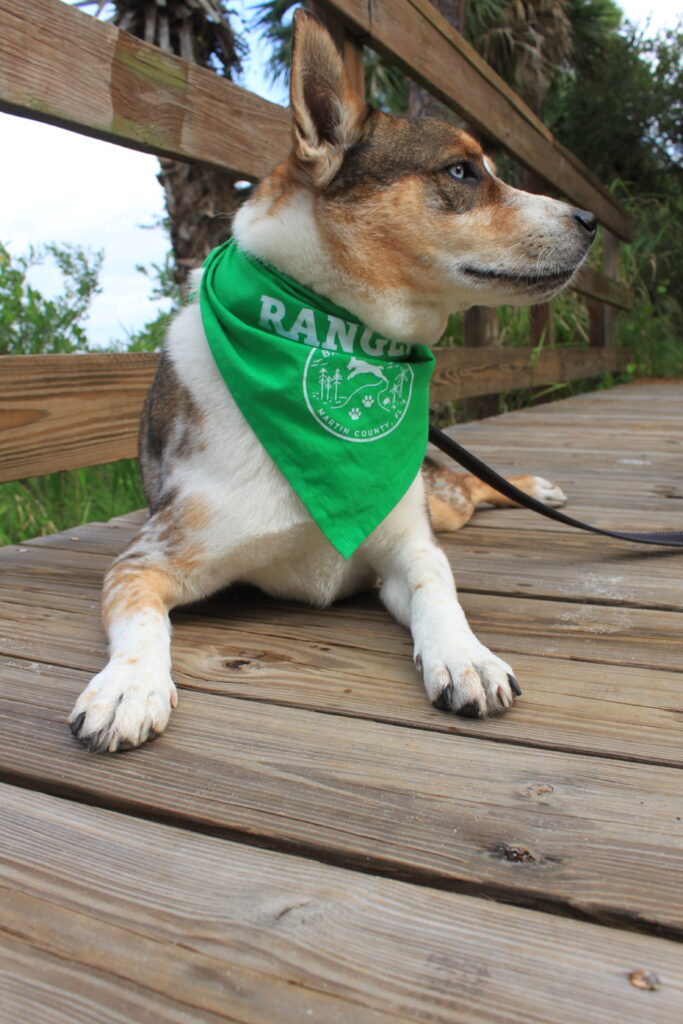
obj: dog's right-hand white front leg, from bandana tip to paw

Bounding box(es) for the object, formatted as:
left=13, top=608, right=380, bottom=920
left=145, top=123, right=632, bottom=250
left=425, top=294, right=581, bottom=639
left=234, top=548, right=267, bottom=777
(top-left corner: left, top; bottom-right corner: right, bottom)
left=364, top=478, right=521, bottom=717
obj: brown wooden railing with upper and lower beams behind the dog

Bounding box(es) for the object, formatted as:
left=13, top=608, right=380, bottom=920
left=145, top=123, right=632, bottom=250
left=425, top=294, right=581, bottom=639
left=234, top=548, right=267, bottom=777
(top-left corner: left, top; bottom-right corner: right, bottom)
left=0, top=0, right=631, bottom=480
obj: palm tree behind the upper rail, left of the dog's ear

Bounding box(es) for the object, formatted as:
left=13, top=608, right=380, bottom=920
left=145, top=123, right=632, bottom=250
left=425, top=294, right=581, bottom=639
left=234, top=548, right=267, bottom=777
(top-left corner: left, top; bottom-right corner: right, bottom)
left=76, top=0, right=246, bottom=285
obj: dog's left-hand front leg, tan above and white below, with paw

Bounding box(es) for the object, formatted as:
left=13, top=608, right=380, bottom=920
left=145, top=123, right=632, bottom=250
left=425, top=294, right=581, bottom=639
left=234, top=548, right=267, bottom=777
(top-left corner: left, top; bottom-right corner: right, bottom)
left=69, top=510, right=222, bottom=752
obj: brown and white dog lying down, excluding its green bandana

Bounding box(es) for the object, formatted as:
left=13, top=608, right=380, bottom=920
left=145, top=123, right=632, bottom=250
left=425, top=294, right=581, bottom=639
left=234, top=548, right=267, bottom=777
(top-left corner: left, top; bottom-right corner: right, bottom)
left=70, top=11, right=595, bottom=751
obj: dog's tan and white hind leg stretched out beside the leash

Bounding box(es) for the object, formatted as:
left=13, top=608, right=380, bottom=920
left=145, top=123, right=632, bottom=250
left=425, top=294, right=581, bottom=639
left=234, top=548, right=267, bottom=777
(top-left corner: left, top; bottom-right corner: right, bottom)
left=423, top=460, right=566, bottom=534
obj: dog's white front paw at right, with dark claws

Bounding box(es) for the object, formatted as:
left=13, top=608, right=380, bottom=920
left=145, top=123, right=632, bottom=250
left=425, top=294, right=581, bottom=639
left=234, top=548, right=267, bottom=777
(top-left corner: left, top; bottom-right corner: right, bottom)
left=415, top=638, right=521, bottom=718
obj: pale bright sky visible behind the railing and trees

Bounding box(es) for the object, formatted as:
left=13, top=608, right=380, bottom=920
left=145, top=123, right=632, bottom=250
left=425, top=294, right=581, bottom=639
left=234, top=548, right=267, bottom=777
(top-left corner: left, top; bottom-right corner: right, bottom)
left=0, top=0, right=683, bottom=346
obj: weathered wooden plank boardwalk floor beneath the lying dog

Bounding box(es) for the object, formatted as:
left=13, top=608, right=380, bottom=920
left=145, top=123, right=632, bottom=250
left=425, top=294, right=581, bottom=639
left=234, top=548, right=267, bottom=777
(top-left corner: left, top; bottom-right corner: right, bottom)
left=0, top=382, right=683, bottom=1024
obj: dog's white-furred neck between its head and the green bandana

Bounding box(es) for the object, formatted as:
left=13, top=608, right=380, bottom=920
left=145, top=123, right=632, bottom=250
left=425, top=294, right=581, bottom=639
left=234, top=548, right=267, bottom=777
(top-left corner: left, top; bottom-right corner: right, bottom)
left=232, top=189, right=451, bottom=345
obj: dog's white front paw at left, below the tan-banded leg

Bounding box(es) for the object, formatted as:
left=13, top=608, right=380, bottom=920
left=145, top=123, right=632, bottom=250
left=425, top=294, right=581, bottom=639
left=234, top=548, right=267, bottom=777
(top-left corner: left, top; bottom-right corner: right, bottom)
left=69, top=662, right=178, bottom=754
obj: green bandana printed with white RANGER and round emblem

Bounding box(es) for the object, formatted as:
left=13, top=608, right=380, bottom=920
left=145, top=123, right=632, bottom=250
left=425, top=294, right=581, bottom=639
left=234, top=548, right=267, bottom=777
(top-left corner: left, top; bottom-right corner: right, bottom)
left=200, top=242, right=434, bottom=558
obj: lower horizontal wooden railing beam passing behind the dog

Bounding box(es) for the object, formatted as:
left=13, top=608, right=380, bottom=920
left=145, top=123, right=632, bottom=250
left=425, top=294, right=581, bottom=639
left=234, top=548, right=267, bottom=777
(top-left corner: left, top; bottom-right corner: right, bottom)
left=0, top=348, right=628, bottom=481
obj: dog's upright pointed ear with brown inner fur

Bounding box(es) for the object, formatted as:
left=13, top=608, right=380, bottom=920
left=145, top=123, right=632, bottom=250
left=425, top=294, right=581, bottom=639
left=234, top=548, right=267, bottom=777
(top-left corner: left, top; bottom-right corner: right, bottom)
left=290, top=8, right=368, bottom=188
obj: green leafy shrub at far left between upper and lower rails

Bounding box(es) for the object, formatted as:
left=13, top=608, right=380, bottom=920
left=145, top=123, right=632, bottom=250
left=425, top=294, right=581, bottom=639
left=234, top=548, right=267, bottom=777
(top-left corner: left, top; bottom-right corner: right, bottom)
left=0, top=244, right=103, bottom=355
